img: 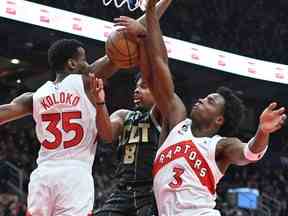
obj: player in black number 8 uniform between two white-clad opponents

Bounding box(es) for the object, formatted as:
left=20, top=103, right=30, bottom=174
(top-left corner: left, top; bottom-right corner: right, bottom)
left=94, top=0, right=171, bottom=216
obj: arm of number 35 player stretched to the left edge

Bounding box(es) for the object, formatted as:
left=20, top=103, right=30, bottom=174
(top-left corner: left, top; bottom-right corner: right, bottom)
left=0, top=92, right=33, bottom=125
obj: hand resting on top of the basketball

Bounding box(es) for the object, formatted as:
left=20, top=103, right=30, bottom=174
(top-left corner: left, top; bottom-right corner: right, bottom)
left=114, top=16, right=146, bottom=40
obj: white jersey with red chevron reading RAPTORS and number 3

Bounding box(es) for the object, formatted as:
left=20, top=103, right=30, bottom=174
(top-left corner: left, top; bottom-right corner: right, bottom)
left=153, top=119, right=223, bottom=216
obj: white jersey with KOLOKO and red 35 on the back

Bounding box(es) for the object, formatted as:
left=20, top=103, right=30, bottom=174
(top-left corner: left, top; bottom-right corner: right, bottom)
left=33, top=74, right=97, bottom=168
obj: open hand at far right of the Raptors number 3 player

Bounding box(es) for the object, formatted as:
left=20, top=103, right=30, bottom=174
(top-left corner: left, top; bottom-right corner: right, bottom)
left=259, top=103, right=287, bottom=133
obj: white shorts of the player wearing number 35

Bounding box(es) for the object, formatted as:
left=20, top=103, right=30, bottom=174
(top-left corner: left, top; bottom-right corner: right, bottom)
left=27, top=161, right=94, bottom=216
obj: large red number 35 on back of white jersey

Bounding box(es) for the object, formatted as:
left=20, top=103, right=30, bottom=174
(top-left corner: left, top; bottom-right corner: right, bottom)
left=41, top=111, right=84, bottom=149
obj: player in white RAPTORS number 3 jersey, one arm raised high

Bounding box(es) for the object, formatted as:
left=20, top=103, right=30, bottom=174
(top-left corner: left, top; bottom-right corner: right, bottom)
left=134, top=0, right=286, bottom=216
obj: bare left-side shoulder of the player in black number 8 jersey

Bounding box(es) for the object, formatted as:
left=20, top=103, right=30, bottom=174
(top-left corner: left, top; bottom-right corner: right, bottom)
left=110, top=109, right=130, bottom=141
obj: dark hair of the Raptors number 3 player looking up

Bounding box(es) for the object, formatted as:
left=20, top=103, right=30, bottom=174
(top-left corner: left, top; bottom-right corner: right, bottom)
left=216, top=87, right=245, bottom=137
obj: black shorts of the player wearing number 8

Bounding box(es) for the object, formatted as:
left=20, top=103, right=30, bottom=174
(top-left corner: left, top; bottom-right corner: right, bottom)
left=93, top=185, right=158, bottom=216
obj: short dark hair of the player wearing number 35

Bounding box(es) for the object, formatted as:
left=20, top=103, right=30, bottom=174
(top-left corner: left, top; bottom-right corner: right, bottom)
left=48, top=39, right=83, bottom=72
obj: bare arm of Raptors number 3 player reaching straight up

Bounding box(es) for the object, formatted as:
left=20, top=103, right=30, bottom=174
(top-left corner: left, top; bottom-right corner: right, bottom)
left=140, top=0, right=186, bottom=136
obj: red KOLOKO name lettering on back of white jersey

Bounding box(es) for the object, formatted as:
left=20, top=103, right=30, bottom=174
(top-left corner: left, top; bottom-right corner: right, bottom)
left=41, top=92, right=80, bottom=110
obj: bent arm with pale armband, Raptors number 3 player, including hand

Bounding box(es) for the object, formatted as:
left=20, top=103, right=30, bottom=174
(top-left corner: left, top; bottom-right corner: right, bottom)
left=219, top=103, right=287, bottom=165
